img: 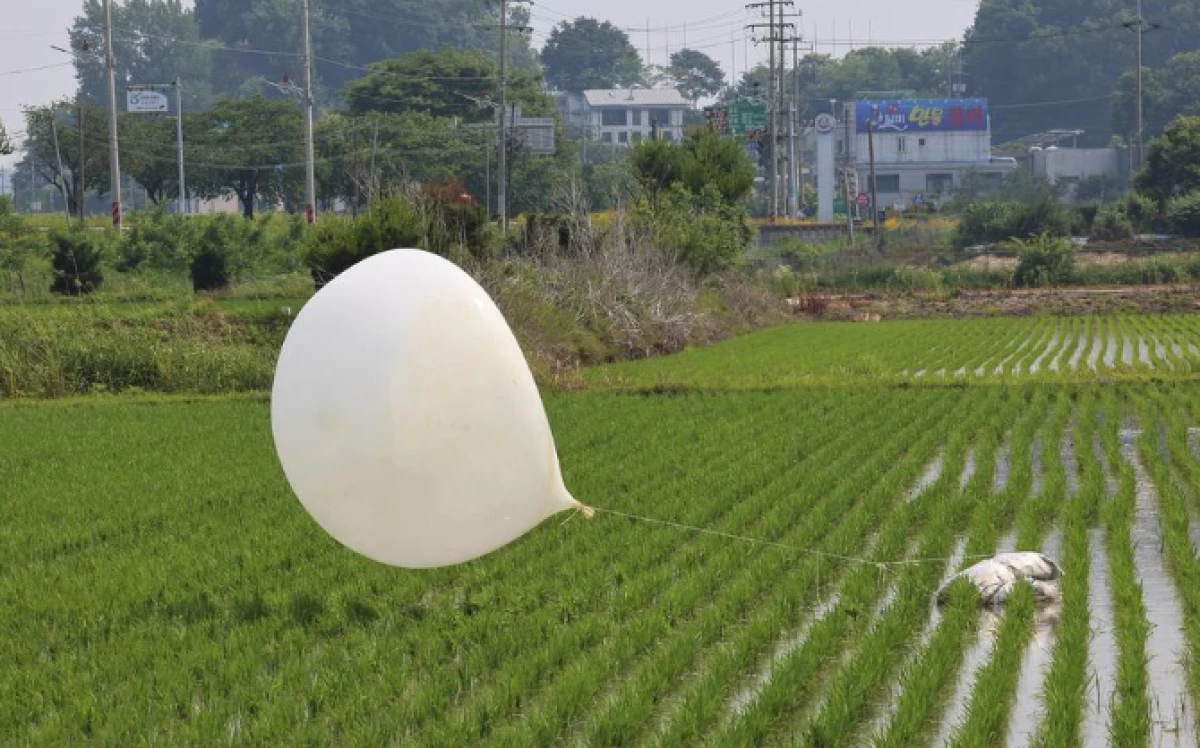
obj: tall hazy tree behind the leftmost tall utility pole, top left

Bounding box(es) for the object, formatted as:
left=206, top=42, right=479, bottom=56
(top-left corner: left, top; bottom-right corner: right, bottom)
left=71, top=0, right=212, bottom=112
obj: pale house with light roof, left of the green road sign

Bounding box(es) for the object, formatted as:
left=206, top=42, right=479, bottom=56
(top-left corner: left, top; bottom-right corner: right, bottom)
left=556, top=89, right=688, bottom=145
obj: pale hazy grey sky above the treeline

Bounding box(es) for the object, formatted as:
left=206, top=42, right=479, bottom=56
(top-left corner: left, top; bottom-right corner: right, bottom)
left=0, top=0, right=976, bottom=167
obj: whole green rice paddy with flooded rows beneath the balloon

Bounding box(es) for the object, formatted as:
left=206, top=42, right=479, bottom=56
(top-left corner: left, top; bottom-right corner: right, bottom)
left=0, top=316, right=1200, bottom=747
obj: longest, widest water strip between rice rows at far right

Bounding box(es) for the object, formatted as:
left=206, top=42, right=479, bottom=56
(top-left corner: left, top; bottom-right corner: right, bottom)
left=1121, top=429, right=1196, bottom=747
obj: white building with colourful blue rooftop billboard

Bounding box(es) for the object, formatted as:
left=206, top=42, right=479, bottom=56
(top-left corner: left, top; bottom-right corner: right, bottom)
left=847, top=98, right=1016, bottom=208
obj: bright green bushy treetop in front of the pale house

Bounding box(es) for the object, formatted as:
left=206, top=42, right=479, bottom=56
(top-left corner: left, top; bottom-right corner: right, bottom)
left=630, top=128, right=755, bottom=205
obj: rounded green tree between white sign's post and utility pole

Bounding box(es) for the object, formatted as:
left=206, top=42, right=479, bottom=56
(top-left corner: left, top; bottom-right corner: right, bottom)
left=187, top=96, right=304, bottom=219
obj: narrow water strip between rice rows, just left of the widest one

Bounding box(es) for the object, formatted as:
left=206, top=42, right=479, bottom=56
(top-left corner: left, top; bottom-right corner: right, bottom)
left=1080, top=528, right=1117, bottom=748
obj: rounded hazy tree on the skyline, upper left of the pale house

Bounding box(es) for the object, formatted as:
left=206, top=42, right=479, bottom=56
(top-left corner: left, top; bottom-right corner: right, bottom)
left=541, top=18, right=642, bottom=91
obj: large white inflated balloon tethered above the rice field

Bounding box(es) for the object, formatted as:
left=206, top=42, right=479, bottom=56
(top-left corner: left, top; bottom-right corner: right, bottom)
left=271, top=250, right=583, bottom=568
